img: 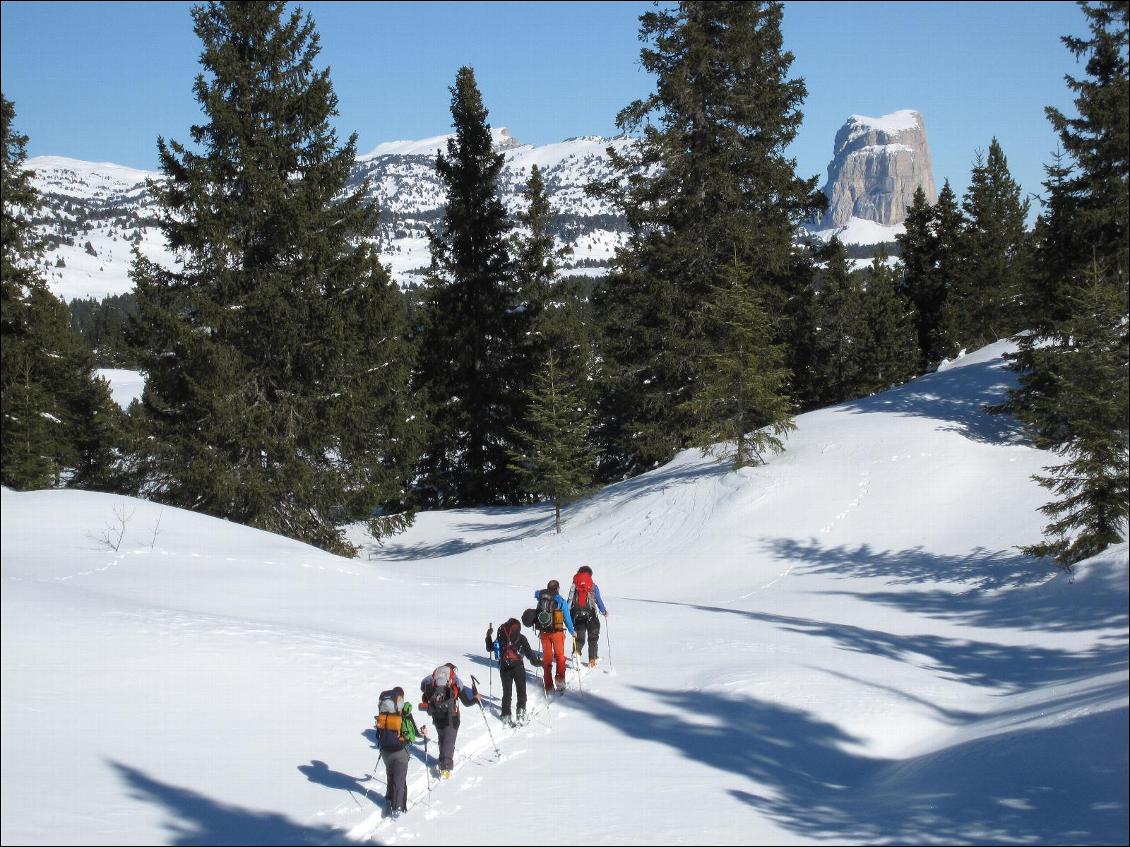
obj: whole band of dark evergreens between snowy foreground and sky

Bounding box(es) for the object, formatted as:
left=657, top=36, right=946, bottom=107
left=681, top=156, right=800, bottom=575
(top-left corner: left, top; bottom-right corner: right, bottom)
left=3, top=2, right=1127, bottom=571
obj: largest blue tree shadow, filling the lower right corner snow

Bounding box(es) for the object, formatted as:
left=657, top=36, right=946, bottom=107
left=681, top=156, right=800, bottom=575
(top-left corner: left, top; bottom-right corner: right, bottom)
left=585, top=688, right=1127, bottom=844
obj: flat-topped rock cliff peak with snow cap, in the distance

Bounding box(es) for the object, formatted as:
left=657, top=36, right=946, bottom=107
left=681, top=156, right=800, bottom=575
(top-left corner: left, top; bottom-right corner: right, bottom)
left=818, top=110, right=938, bottom=229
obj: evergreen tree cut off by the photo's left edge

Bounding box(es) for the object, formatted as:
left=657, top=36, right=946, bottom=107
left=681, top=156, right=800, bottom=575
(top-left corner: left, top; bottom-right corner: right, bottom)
left=0, top=95, right=121, bottom=489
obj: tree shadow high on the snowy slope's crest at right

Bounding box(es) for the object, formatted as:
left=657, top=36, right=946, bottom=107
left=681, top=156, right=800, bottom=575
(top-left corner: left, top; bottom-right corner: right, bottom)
left=840, top=359, right=1025, bottom=444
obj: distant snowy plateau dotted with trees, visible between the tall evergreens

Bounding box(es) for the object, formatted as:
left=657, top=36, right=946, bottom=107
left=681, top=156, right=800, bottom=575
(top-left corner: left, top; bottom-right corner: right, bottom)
left=26, top=128, right=631, bottom=300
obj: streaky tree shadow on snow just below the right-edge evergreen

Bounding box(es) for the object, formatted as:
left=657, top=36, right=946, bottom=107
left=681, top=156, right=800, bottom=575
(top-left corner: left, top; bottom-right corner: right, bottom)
left=767, top=539, right=1130, bottom=631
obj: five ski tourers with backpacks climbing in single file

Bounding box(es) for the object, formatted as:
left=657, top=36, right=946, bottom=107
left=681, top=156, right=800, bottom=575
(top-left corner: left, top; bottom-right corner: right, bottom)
left=376, top=565, right=608, bottom=817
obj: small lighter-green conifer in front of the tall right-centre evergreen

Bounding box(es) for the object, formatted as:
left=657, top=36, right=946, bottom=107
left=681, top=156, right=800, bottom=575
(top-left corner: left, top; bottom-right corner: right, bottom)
left=687, top=262, right=796, bottom=470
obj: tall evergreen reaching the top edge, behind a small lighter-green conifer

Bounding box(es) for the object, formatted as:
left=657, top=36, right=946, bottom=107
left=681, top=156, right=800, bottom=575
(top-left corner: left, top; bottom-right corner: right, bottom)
left=594, top=1, right=826, bottom=478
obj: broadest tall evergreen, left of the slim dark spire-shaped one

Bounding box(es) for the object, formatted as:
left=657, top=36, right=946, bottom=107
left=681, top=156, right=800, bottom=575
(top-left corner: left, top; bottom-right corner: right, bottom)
left=133, top=0, right=415, bottom=553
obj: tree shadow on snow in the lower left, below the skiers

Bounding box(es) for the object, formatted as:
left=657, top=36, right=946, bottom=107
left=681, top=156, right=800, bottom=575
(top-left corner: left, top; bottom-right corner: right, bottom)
left=108, top=761, right=351, bottom=845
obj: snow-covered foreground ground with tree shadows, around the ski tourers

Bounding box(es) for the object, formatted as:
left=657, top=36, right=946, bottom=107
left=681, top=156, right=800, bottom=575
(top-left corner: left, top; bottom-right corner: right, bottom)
left=0, top=344, right=1128, bottom=844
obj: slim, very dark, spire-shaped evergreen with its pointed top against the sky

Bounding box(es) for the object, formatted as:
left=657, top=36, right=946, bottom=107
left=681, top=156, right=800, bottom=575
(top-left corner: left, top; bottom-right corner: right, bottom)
left=417, top=68, right=517, bottom=507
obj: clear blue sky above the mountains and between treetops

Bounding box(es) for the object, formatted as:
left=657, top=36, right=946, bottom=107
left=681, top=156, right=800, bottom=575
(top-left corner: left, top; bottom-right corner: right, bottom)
left=0, top=2, right=1086, bottom=208
